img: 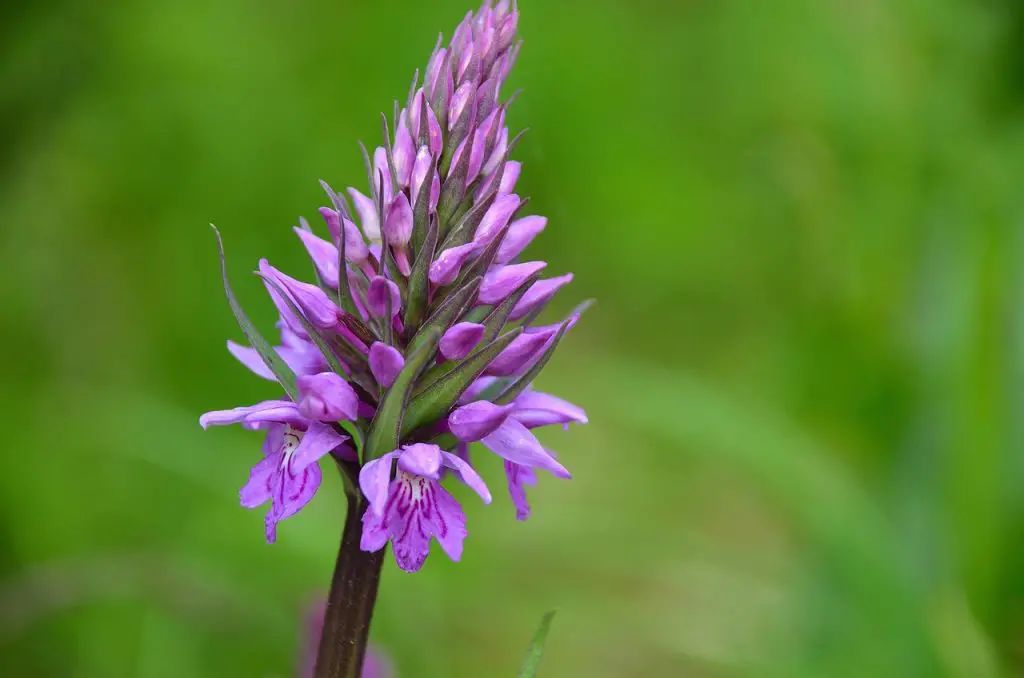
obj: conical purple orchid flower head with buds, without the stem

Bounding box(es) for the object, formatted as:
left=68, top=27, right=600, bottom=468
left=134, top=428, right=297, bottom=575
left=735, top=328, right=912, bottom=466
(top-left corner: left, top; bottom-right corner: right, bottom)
left=200, top=0, right=587, bottom=571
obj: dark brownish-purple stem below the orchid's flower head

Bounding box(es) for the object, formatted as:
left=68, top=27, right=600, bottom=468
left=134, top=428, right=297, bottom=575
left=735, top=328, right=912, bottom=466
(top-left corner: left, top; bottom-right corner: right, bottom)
left=313, top=494, right=386, bottom=678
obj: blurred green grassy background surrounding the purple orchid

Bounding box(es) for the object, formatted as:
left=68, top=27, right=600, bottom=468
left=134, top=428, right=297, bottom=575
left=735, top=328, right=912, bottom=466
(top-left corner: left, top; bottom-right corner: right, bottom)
left=0, top=0, right=1024, bottom=678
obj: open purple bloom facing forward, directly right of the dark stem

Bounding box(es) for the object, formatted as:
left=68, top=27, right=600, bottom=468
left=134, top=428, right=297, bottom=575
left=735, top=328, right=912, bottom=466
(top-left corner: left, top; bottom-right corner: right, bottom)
left=359, top=442, right=490, bottom=573
